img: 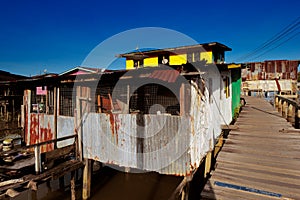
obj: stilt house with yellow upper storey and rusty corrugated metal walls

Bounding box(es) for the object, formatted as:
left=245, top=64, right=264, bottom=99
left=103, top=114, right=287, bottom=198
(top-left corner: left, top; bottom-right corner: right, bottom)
left=23, top=42, right=241, bottom=176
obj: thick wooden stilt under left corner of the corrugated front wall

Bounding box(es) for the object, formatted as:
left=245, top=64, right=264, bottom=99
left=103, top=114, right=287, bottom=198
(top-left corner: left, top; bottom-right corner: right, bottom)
left=82, top=159, right=92, bottom=200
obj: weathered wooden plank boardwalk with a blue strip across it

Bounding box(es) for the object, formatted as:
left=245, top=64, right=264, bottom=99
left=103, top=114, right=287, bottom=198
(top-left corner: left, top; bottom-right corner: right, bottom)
left=201, top=97, right=300, bottom=200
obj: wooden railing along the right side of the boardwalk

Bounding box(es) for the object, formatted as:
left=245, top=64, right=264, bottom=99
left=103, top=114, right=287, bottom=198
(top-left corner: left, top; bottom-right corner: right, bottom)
left=274, top=95, right=299, bottom=129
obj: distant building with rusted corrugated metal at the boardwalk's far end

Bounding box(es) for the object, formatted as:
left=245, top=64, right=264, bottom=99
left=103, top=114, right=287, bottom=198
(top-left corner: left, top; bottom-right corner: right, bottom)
left=242, top=60, right=300, bottom=97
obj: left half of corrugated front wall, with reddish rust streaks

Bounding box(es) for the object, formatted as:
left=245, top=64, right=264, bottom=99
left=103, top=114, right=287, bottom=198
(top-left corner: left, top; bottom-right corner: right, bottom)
left=83, top=113, right=137, bottom=168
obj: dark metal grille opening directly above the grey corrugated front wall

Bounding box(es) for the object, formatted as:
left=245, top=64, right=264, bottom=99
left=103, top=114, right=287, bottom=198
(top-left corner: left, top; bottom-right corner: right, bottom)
left=92, top=84, right=180, bottom=115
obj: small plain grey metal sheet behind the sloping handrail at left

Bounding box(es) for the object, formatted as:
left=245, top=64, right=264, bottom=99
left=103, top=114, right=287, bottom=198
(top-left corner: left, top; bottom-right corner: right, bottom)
left=57, top=116, right=75, bottom=148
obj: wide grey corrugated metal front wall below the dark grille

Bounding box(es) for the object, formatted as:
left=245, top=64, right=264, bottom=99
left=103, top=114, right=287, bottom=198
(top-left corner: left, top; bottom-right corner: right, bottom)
left=83, top=113, right=190, bottom=175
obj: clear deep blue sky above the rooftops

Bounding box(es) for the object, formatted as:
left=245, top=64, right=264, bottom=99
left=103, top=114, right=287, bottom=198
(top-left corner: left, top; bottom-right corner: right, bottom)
left=0, top=0, right=300, bottom=75
